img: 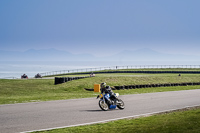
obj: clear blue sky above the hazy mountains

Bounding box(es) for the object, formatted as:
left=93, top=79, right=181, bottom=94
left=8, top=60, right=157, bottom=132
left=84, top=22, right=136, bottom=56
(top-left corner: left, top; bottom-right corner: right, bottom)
left=0, top=0, right=200, bottom=56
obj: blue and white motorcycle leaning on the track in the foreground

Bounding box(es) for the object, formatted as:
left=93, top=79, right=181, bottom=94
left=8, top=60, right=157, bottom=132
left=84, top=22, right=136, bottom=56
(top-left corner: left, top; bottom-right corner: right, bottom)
left=97, top=93, right=125, bottom=111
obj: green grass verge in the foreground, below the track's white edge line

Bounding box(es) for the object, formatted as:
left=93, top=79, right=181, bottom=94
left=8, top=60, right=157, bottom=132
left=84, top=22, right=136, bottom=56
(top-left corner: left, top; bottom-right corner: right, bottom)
left=36, top=108, right=200, bottom=133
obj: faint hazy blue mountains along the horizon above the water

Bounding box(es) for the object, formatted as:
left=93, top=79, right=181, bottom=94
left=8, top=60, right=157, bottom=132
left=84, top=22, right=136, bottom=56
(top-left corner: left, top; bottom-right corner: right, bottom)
left=0, top=48, right=200, bottom=61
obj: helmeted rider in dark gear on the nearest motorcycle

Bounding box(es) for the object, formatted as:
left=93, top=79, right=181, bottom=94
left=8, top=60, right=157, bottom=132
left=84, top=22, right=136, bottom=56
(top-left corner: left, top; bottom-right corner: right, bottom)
left=98, top=82, right=117, bottom=104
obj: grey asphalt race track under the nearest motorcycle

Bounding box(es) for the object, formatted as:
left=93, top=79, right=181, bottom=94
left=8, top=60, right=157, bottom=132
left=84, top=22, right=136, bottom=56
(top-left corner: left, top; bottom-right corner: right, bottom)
left=0, top=89, right=200, bottom=133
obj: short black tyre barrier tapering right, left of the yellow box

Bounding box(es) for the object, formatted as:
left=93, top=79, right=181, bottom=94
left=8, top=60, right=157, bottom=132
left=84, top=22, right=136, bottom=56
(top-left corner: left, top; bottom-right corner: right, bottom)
left=54, top=76, right=90, bottom=85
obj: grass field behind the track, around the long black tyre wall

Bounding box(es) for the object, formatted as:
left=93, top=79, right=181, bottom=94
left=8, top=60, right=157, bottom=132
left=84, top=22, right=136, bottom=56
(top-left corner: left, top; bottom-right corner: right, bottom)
left=0, top=74, right=200, bottom=104
